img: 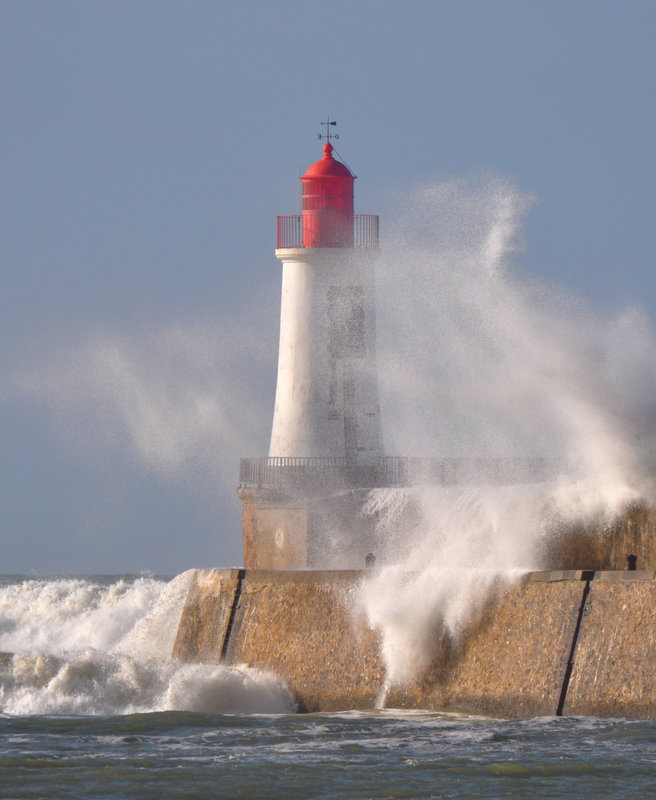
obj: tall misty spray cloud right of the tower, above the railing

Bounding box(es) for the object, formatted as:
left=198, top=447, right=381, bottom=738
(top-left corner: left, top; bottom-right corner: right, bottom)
left=377, top=179, right=656, bottom=489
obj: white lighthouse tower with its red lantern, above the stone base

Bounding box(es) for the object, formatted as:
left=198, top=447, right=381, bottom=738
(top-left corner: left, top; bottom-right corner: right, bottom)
left=269, top=136, right=381, bottom=465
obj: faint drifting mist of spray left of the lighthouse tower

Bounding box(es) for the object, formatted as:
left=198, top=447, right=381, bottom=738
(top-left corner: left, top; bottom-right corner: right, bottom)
left=8, top=312, right=275, bottom=498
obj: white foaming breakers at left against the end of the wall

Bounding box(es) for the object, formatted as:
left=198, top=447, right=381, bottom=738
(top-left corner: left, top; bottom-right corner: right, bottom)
left=0, top=572, right=294, bottom=715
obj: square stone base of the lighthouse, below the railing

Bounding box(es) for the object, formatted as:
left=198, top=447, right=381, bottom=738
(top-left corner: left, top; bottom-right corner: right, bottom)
left=237, top=488, right=376, bottom=569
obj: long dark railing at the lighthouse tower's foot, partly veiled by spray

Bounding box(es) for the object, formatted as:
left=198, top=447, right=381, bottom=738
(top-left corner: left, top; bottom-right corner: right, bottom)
left=239, top=456, right=565, bottom=490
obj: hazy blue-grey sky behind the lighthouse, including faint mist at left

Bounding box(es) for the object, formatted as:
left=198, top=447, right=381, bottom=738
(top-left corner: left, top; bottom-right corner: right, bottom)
left=0, top=0, right=656, bottom=574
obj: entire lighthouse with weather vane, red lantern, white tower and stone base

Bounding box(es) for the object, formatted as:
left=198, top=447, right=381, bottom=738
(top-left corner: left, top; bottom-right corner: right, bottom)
left=238, top=126, right=383, bottom=568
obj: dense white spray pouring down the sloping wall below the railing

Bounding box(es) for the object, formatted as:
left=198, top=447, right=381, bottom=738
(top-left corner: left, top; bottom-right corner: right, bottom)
left=360, top=486, right=545, bottom=686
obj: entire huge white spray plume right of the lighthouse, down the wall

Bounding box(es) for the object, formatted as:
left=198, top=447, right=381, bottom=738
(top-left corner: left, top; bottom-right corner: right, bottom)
left=361, top=178, right=656, bottom=700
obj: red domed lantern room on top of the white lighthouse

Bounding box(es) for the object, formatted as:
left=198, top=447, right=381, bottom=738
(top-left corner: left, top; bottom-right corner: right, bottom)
left=301, top=142, right=355, bottom=247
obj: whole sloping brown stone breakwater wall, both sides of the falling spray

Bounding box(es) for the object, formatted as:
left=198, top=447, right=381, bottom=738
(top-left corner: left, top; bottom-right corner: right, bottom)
left=173, top=569, right=656, bottom=718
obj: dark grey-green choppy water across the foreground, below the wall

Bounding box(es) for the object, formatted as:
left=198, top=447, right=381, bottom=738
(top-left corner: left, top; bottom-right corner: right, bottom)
left=7, top=711, right=656, bottom=798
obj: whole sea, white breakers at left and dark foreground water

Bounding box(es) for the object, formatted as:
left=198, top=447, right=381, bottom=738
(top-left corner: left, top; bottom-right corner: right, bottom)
left=0, top=573, right=656, bottom=800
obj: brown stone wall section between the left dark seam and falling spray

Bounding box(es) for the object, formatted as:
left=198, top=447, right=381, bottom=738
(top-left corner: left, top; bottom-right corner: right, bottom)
left=226, top=570, right=383, bottom=711
